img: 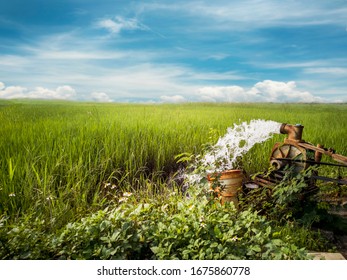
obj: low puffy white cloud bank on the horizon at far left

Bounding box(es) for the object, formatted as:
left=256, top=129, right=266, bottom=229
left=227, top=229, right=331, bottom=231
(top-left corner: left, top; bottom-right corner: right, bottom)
left=0, top=82, right=76, bottom=99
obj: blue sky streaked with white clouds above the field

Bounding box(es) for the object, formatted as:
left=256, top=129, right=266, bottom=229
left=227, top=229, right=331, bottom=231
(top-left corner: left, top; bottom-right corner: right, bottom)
left=0, top=0, right=347, bottom=103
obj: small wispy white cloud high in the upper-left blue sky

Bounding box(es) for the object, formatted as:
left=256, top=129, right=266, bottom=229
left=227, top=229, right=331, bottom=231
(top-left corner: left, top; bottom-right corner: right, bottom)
left=96, top=16, right=147, bottom=34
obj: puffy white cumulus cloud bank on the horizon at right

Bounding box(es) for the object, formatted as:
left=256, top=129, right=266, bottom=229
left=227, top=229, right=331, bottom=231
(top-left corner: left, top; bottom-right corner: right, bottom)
left=198, top=80, right=325, bottom=103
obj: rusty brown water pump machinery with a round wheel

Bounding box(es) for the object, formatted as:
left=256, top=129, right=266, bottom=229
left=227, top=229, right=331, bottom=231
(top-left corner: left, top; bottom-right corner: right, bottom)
left=250, top=123, right=347, bottom=188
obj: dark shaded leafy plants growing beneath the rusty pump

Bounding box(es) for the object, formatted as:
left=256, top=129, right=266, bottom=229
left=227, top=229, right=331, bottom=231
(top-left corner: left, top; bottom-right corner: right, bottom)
left=240, top=167, right=334, bottom=254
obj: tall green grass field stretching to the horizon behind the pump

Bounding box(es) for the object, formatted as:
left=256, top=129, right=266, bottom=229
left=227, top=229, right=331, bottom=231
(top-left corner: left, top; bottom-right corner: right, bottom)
left=0, top=101, right=347, bottom=228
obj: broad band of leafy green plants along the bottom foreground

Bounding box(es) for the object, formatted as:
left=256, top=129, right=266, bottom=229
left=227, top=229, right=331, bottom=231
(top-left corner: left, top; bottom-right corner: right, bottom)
left=0, top=191, right=307, bottom=260
